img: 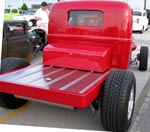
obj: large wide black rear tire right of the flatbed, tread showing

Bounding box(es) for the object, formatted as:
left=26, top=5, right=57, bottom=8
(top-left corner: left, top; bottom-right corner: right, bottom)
left=101, top=70, right=136, bottom=132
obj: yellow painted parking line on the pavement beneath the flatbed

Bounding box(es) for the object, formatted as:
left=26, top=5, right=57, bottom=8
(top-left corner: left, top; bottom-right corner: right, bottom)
left=0, top=102, right=33, bottom=124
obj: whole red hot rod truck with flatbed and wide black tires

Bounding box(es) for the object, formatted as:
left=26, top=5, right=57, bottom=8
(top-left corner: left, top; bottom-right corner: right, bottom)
left=0, top=0, right=148, bottom=132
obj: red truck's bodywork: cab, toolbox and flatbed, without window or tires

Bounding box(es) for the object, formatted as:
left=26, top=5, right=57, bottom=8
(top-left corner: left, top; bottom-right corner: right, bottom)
left=0, top=0, right=132, bottom=108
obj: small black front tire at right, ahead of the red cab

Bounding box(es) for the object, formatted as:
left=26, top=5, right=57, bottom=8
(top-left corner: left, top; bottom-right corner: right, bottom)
left=139, top=46, right=148, bottom=71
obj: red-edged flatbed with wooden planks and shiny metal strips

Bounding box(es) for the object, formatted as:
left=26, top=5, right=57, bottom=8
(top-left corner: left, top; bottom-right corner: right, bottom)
left=0, top=64, right=111, bottom=108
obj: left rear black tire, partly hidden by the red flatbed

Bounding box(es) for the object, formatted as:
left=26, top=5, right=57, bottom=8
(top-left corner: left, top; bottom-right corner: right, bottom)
left=0, top=57, right=29, bottom=109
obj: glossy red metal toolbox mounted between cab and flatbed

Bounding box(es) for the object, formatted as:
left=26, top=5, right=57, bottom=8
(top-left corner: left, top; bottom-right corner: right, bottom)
left=43, top=45, right=111, bottom=72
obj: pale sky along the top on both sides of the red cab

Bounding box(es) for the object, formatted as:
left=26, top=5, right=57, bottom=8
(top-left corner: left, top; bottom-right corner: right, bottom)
left=5, top=0, right=150, bottom=9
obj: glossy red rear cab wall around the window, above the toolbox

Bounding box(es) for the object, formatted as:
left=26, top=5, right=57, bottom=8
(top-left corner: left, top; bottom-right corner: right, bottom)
left=44, top=0, right=132, bottom=69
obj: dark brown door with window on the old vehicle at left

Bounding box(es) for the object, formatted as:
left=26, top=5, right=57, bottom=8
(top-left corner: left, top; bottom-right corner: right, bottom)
left=7, top=21, right=32, bottom=58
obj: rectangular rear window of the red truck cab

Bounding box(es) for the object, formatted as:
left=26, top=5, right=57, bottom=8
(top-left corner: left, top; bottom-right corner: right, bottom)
left=68, top=11, right=103, bottom=26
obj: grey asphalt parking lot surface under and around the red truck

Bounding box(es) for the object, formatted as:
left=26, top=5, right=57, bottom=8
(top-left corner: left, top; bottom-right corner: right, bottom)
left=0, top=28, right=150, bottom=132
